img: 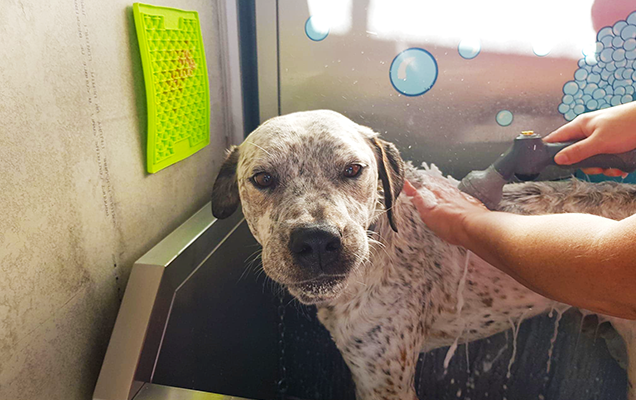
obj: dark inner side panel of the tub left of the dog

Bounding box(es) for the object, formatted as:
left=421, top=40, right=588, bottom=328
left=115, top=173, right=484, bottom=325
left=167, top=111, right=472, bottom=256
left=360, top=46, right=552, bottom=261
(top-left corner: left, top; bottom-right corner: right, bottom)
left=152, top=223, right=278, bottom=398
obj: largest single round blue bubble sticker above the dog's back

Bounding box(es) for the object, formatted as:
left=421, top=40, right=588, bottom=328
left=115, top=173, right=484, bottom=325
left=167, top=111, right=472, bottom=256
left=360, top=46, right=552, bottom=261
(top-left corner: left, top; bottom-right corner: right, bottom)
left=389, top=47, right=438, bottom=96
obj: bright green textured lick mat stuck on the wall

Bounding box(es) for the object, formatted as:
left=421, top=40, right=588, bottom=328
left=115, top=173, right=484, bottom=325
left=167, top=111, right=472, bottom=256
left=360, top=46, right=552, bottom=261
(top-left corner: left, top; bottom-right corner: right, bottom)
left=133, top=3, right=210, bottom=172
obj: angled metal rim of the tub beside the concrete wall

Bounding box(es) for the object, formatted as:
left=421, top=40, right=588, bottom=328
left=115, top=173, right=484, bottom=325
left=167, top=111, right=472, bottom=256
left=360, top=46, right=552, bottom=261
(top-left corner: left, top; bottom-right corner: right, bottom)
left=93, top=203, right=242, bottom=400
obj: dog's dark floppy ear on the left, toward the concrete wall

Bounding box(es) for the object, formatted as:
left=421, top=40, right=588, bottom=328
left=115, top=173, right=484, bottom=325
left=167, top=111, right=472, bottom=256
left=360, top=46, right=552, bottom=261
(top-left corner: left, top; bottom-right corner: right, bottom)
left=212, top=146, right=240, bottom=219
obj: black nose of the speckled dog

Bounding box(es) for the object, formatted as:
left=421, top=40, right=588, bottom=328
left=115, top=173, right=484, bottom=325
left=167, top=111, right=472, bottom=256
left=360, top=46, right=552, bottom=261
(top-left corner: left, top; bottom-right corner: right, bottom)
left=289, top=224, right=342, bottom=274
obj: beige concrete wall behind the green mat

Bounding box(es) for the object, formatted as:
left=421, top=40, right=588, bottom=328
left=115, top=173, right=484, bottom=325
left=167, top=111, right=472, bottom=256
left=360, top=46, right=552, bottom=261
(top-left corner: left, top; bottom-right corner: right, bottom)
left=0, top=0, right=229, bottom=400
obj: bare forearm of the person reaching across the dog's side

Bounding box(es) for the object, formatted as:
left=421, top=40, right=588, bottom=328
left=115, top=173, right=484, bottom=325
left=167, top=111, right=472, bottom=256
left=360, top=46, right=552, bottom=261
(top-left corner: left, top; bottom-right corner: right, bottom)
left=460, top=212, right=636, bottom=319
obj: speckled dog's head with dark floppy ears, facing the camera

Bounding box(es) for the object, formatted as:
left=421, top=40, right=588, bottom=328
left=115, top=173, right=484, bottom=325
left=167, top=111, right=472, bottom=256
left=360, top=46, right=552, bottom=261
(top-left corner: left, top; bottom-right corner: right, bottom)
left=212, top=111, right=403, bottom=304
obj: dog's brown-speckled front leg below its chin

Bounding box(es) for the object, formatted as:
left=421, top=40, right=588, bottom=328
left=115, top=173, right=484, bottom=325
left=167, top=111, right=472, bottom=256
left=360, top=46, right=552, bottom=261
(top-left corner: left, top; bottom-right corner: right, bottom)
left=319, top=313, right=423, bottom=400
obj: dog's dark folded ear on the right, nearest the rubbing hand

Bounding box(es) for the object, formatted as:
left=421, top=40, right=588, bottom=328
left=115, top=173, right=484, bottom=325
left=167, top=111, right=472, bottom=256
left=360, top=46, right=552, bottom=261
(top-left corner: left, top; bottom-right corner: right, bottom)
left=370, top=137, right=404, bottom=232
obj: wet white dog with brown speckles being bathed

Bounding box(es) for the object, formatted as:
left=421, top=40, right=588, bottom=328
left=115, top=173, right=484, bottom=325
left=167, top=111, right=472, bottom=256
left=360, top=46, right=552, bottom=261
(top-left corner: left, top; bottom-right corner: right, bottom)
left=211, top=110, right=636, bottom=400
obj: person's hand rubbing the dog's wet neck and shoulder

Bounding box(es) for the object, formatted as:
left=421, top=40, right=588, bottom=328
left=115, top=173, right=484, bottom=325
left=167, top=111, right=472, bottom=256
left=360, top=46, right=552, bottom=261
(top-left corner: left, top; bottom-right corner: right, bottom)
left=403, top=180, right=490, bottom=245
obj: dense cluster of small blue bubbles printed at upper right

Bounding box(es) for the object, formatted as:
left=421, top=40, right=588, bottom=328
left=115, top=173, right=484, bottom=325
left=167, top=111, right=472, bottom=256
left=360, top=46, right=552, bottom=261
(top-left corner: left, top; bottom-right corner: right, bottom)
left=558, top=11, right=636, bottom=121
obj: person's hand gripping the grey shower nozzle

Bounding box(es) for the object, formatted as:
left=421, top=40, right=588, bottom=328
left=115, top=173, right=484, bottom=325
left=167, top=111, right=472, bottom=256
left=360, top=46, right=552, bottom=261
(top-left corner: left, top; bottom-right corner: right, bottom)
left=544, top=103, right=636, bottom=177
